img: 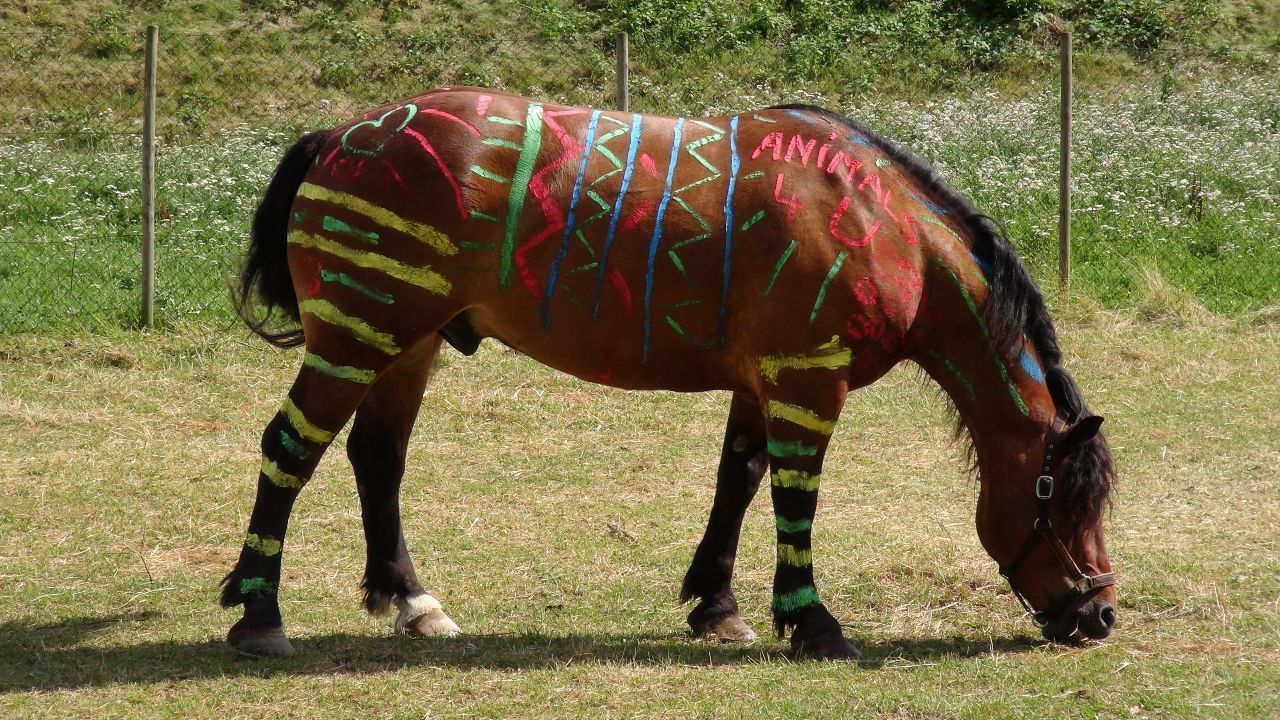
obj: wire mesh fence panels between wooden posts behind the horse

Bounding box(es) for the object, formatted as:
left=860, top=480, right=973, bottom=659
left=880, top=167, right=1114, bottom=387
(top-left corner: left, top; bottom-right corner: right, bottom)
left=0, top=26, right=1280, bottom=331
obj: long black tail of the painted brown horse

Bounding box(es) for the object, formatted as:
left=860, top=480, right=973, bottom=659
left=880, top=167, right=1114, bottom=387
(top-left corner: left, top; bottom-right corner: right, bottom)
left=232, top=131, right=329, bottom=347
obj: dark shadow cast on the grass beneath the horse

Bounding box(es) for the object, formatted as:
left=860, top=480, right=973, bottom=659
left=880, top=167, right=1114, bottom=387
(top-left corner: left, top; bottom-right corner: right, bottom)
left=0, top=604, right=1039, bottom=693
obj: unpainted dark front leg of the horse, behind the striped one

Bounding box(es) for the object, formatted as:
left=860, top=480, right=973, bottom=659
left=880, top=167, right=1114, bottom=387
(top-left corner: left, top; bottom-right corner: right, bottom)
left=680, top=393, right=769, bottom=641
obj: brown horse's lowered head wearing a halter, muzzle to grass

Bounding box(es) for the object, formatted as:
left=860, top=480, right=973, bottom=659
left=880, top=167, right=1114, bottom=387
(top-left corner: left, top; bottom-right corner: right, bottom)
left=978, top=415, right=1116, bottom=643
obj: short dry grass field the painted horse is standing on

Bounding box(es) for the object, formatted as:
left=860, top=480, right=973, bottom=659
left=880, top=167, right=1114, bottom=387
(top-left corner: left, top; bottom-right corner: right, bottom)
left=0, top=310, right=1280, bottom=720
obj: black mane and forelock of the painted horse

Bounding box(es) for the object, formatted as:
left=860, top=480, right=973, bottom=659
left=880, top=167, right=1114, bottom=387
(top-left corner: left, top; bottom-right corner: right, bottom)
left=774, top=105, right=1115, bottom=523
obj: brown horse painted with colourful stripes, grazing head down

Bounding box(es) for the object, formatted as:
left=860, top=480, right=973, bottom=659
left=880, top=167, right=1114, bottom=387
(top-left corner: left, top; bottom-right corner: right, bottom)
left=221, top=88, right=1115, bottom=657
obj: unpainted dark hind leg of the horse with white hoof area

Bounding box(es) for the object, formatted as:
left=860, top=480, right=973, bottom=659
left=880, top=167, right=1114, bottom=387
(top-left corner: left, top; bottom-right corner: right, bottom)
left=347, top=334, right=458, bottom=635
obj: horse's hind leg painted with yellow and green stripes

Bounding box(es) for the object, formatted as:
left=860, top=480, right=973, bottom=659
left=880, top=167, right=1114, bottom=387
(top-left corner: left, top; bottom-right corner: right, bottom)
left=221, top=332, right=390, bottom=656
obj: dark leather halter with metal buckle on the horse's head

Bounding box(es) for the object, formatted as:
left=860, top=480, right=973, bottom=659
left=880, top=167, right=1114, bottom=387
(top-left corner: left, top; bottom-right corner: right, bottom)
left=1000, top=416, right=1116, bottom=626
